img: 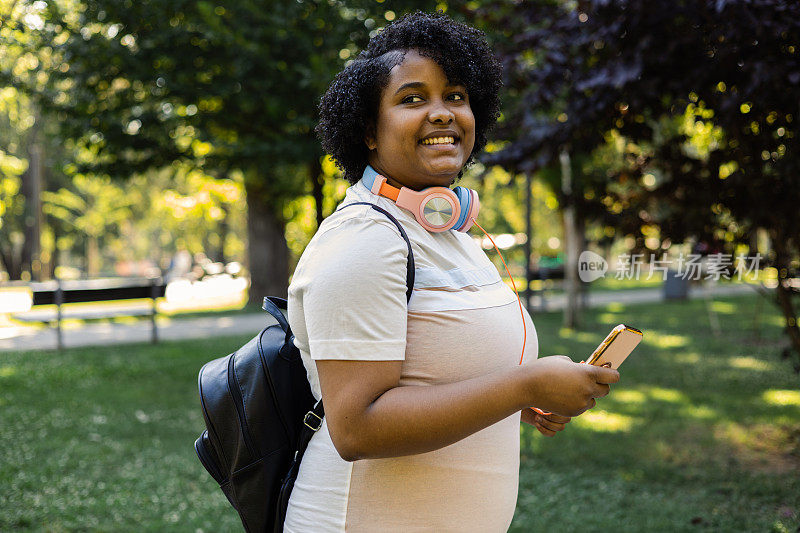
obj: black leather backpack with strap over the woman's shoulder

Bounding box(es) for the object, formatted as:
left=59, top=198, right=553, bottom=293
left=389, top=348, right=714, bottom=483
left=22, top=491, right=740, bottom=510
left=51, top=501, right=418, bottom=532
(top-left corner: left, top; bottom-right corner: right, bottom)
left=194, top=202, right=414, bottom=533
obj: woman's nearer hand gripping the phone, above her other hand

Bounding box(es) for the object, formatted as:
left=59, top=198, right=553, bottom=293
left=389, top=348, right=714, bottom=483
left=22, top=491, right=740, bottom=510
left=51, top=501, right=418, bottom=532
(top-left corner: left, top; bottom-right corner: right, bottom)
left=523, top=355, right=619, bottom=416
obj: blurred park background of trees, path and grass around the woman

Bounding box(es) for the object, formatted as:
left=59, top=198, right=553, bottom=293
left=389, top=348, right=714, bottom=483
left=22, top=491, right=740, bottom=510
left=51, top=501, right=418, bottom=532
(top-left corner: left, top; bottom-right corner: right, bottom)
left=0, top=0, right=800, bottom=531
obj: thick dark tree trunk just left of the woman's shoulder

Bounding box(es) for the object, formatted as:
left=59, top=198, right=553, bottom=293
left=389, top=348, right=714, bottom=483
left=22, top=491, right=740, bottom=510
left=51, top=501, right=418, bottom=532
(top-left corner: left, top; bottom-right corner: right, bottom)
left=245, top=183, right=289, bottom=303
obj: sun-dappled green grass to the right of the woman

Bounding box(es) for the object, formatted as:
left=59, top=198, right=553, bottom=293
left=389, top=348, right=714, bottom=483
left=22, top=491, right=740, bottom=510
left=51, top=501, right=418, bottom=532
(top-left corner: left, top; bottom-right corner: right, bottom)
left=512, top=296, right=800, bottom=532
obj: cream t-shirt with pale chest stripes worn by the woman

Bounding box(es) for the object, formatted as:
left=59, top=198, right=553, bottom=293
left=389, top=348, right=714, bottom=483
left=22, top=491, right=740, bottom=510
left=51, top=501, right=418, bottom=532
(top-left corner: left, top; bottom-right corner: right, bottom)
left=284, top=182, right=538, bottom=532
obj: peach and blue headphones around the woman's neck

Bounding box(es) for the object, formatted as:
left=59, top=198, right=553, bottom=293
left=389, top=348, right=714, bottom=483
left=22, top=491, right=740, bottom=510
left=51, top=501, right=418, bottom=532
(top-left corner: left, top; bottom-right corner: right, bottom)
left=361, top=165, right=481, bottom=233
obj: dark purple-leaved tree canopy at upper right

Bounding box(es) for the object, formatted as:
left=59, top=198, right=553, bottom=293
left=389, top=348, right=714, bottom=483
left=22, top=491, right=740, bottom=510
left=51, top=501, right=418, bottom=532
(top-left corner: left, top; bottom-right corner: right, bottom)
left=482, top=0, right=800, bottom=366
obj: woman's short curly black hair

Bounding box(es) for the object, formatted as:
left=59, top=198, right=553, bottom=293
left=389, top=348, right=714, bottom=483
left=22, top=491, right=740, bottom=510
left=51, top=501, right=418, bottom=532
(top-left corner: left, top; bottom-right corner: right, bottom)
left=315, top=11, right=502, bottom=183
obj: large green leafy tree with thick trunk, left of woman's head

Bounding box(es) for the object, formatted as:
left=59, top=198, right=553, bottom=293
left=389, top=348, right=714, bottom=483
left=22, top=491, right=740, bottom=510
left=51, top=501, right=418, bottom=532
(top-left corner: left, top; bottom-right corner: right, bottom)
left=17, top=0, right=430, bottom=299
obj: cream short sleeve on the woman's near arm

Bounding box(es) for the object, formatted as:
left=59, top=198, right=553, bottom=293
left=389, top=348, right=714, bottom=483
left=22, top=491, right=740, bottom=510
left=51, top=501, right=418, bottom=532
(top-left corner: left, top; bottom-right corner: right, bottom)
left=289, top=210, right=408, bottom=361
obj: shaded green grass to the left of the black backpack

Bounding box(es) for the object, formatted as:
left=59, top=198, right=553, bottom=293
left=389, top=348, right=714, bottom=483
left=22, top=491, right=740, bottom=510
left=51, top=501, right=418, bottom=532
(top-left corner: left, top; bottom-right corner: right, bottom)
left=0, top=337, right=247, bottom=532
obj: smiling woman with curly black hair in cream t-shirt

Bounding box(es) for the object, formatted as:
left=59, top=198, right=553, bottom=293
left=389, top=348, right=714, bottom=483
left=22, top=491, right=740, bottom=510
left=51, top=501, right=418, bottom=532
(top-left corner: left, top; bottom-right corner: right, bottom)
left=285, top=13, right=619, bottom=532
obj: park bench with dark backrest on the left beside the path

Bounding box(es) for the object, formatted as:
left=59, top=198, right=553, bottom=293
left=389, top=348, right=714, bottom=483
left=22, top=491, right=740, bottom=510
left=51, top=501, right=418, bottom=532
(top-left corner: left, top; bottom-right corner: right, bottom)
left=12, top=278, right=166, bottom=349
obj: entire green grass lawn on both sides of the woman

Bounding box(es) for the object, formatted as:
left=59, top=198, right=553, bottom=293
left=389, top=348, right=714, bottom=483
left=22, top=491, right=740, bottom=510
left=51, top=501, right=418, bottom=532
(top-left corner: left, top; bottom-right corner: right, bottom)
left=0, top=296, right=800, bottom=532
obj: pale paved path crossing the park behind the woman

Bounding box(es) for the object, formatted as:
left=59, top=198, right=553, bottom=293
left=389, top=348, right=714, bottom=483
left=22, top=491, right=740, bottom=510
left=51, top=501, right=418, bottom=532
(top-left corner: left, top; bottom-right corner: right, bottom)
left=0, top=285, right=754, bottom=352
